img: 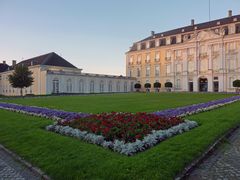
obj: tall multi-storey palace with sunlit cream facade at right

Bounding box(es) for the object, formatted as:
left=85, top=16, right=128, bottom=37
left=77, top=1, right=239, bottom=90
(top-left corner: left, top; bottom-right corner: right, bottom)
left=126, top=11, right=240, bottom=92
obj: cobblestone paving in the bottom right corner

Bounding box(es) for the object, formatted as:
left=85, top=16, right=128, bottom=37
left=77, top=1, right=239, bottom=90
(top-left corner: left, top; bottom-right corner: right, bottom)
left=187, top=129, right=240, bottom=180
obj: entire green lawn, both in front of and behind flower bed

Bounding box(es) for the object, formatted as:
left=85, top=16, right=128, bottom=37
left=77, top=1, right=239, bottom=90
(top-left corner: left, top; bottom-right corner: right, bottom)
left=0, top=93, right=240, bottom=179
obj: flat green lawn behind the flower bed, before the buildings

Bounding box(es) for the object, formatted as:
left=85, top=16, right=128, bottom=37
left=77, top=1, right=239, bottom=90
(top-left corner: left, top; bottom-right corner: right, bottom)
left=0, top=93, right=233, bottom=113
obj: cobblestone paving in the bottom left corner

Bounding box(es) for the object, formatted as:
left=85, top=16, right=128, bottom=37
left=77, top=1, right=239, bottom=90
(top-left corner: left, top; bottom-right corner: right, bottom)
left=0, top=149, right=41, bottom=180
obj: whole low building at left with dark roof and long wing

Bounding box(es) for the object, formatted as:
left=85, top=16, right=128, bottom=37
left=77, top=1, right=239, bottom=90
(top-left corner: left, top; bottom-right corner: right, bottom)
left=0, top=52, right=136, bottom=96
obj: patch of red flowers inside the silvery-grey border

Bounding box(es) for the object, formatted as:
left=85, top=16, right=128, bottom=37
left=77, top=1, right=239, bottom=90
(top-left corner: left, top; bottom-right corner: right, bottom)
left=57, top=112, right=183, bottom=142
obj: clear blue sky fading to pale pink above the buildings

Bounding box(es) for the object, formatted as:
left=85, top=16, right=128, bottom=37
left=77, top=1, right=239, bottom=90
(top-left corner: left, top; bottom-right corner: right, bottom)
left=0, top=0, right=240, bottom=75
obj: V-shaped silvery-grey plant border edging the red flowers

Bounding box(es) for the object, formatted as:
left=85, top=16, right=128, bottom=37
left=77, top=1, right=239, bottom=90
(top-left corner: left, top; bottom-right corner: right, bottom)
left=46, top=120, right=198, bottom=156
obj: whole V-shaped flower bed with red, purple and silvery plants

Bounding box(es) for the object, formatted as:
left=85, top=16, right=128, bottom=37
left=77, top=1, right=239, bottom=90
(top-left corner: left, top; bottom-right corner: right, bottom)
left=0, top=96, right=240, bottom=155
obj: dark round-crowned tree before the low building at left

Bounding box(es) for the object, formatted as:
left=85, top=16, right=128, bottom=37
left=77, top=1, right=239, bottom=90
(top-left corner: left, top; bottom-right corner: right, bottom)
left=8, top=65, right=33, bottom=96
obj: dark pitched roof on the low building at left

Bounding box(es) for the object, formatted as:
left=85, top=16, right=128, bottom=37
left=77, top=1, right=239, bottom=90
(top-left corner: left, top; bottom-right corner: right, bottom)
left=17, top=52, right=77, bottom=68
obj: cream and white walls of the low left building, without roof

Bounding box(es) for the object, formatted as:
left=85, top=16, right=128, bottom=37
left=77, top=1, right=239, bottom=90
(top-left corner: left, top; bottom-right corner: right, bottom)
left=0, top=65, right=136, bottom=96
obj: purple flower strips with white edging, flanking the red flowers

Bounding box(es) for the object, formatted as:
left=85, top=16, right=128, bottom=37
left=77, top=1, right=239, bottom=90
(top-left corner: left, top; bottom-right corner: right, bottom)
left=0, top=96, right=240, bottom=121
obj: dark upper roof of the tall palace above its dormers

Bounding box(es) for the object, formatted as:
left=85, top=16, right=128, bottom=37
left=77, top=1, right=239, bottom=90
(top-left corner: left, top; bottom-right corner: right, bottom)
left=139, top=15, right=240, bottom=42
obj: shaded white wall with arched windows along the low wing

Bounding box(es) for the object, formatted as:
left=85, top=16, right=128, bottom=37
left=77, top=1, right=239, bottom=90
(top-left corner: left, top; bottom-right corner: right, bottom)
left=46, top=71, right=136, bottom=94
